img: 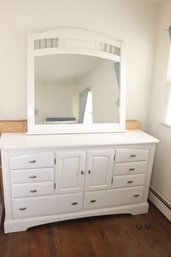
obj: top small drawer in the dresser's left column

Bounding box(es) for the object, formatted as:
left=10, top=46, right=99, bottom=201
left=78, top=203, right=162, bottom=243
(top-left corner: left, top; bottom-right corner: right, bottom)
left=10, top=152, right=54, bottom=170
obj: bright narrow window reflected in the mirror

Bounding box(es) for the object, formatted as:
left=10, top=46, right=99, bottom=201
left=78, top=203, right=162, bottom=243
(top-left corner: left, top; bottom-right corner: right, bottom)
left=83, top=91, right=93, bottom=124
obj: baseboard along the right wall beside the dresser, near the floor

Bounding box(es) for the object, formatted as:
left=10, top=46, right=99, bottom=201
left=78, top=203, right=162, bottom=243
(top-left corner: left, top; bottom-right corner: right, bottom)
left=149, top=186, right=171, bottom=221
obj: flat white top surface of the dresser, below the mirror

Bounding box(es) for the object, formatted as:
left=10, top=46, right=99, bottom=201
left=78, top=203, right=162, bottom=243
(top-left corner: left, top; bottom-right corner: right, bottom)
left=0, top=130, right=159, bottom=149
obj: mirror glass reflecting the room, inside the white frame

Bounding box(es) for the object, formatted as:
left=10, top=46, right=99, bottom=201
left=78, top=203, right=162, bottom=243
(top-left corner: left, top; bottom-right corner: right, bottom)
left=34, top=54, right=120, bottom=124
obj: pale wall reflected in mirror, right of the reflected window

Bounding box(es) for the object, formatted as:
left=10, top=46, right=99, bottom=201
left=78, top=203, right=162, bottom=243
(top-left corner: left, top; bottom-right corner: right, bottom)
left=77, top=60, right=119, bottom=123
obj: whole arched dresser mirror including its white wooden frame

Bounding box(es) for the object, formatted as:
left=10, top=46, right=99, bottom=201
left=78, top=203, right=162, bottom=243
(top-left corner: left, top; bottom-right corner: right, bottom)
left=28, top=29, right=125, bottom=134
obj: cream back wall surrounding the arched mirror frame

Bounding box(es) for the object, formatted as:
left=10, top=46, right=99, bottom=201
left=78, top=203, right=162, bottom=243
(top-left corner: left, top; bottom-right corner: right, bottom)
left=0, top=0, right=158, bottom=129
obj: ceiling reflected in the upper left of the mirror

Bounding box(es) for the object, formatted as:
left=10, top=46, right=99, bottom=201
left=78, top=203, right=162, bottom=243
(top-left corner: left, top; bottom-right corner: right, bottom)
left=35, top=54, right=105, bottom=85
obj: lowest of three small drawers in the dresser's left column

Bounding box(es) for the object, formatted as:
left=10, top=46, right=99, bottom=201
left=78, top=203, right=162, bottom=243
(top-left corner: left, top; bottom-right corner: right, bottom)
left=11, top=182, right=54, bottom=198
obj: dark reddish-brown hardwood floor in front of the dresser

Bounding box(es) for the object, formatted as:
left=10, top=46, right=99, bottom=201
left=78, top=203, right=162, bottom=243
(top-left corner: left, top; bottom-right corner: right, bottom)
left=0, top=204, right=171, bottom=257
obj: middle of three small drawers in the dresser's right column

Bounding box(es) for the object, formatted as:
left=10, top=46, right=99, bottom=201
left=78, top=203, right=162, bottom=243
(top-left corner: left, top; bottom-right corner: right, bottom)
left=114, top=161, right=148, bottom=175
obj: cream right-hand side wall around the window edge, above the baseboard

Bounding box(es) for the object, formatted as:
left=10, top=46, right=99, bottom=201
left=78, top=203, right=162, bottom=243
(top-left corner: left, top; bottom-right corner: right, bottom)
left=149, top=0, right=171, bottom=204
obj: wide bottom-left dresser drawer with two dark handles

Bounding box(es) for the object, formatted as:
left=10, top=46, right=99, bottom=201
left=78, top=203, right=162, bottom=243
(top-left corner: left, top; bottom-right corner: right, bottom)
left=12, top=193, right=83, bottom=219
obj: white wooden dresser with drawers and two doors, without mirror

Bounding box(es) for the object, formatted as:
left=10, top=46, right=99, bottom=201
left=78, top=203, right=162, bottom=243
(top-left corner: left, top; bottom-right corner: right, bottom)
left=0, top=131, right=158, bottom=233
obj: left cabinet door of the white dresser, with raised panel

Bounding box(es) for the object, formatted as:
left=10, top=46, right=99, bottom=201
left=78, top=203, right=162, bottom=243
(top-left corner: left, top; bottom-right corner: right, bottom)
left=56, top=150, right=85, bottom=193
